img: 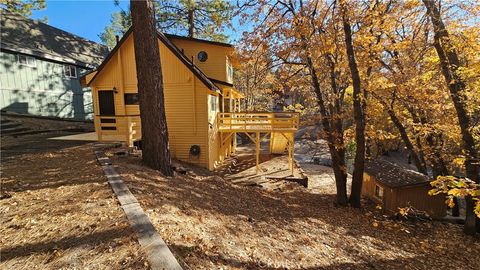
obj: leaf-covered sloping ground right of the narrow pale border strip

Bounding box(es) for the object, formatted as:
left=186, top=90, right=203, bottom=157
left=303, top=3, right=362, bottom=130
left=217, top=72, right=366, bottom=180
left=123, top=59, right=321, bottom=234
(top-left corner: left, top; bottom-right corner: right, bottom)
left=112, top=150, right=480, bottom=269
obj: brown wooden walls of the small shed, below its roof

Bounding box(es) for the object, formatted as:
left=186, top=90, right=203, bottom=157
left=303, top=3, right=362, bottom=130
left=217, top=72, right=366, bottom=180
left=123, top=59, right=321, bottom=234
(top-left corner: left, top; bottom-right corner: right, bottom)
left=362, top=173, right=447, bottom=218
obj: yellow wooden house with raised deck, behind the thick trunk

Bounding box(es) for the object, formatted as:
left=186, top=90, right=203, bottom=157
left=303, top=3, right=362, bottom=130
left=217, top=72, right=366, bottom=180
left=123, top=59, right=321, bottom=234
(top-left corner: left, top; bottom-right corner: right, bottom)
left=82, top=30, right=298, bottom=171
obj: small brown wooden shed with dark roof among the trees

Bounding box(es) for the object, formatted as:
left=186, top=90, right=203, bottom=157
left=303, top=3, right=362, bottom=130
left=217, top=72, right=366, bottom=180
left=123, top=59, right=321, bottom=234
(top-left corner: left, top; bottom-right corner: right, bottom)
left=362, top=160, right=447, bottom=218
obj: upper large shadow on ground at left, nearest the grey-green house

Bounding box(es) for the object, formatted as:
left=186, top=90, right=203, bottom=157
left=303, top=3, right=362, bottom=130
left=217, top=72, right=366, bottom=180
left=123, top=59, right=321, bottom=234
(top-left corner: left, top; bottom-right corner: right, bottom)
left=2, top=140, right=106, bottom=194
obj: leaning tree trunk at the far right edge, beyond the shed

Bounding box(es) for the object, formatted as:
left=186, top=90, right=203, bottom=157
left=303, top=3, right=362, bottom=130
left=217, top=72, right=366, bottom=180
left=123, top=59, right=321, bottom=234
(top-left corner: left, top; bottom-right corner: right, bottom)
left=423, top=0, right=480, bottom=234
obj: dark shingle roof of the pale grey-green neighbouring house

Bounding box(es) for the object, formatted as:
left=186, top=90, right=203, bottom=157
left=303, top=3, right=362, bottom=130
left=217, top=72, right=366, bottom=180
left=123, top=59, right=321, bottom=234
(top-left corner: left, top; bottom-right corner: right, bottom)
left=0, top=9, right=108, bottom=68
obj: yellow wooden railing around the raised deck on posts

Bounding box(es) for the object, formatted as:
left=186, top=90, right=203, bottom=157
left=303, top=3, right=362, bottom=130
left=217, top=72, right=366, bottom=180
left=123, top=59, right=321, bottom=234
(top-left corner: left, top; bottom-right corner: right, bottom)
left=217, top=112, right=300, bottom=132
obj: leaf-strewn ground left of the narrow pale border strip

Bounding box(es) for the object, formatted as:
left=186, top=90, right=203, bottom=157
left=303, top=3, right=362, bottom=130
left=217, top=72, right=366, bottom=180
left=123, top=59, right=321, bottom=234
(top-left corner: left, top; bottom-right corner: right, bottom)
left=0, top=115, right=148, bottom=269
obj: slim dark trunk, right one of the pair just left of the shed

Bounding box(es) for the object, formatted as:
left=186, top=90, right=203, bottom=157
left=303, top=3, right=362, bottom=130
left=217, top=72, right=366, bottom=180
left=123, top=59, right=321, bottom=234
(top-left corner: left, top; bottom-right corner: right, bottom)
left=342, top=7, right=365, bottom=207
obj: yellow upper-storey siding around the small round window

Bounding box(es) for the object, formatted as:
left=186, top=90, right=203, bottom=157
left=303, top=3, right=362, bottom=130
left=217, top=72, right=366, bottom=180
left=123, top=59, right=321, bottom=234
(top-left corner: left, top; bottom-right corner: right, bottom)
left=170, top=38, right=232, bottom=82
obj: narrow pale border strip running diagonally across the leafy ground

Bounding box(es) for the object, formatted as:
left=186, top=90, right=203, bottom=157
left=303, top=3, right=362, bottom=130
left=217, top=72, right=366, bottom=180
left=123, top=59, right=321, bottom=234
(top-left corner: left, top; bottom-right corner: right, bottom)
left=95, top=151, right=182, bottom=270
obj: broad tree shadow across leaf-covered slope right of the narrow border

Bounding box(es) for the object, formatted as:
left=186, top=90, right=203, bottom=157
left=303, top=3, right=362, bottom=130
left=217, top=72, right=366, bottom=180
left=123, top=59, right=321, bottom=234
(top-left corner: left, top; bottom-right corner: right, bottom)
left=116, top=153, right=476, bottom=269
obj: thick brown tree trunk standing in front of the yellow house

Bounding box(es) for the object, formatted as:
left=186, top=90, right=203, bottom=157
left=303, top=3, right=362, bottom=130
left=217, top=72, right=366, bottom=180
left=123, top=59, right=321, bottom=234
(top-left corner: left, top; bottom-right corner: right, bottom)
left=130, top=0, right=173, bottom=176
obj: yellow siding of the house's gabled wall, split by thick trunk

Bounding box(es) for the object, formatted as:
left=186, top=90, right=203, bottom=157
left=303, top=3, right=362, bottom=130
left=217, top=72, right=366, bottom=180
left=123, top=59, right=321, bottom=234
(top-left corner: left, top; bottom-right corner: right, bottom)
left=91, top=34, right=215, bottom=169
